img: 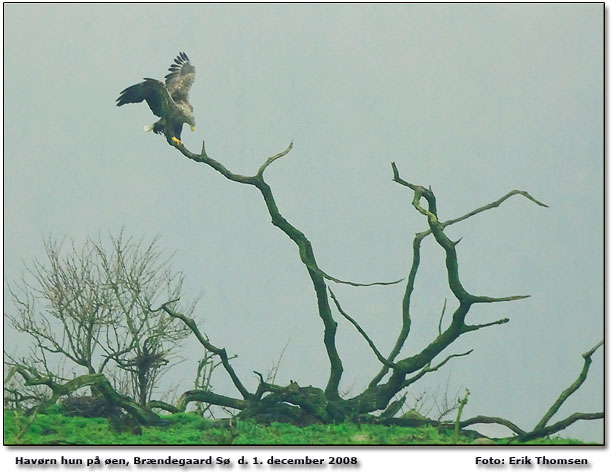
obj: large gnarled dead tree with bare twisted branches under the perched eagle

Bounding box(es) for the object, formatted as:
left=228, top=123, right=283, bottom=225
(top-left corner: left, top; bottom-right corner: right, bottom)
left=158, top=136, right=602, bottom=438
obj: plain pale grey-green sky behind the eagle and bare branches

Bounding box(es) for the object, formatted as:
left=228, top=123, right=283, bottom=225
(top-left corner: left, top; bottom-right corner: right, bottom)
left=4, top=4, right=603, bottom=440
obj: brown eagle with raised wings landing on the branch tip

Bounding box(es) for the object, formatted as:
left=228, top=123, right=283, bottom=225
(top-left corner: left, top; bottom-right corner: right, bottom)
left=117, top=52, right=195, bottom=142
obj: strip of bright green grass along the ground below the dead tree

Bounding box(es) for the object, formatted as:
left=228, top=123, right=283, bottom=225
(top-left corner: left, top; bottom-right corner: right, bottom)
left=4, top=411, right=582, bottom=445
